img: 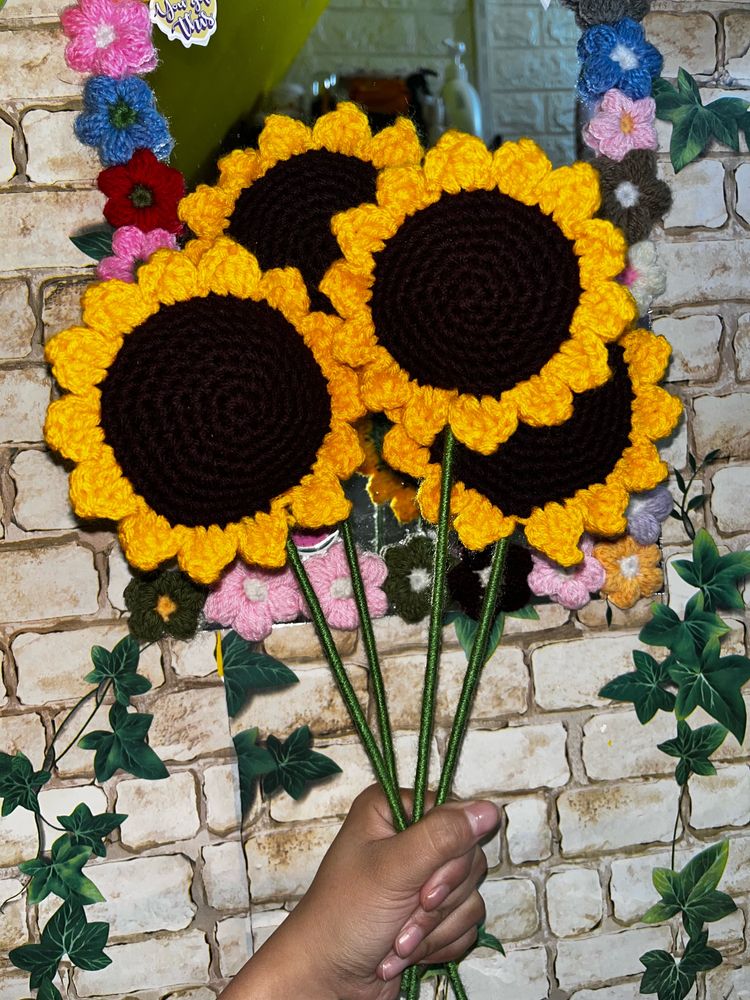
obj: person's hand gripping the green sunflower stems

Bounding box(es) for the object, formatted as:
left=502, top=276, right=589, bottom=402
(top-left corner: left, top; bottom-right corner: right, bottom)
left=222, top=786, right=506, bottom=1000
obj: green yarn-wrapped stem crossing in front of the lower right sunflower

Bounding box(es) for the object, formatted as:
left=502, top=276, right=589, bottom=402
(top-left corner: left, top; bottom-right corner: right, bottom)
left=412, top=427, right=455, bottom=823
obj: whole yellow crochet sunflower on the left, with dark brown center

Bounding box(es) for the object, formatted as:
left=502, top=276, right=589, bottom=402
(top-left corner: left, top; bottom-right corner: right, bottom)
left=45, top=238, right=364, bottom=583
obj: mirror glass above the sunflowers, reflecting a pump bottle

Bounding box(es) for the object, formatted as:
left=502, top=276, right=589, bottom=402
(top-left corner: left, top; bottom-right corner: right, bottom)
left=149, top=0, right=579, bottom=187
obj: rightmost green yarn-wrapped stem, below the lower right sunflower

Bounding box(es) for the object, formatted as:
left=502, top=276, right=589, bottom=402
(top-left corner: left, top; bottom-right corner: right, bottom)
left=435, top=538, right=508, bottom=805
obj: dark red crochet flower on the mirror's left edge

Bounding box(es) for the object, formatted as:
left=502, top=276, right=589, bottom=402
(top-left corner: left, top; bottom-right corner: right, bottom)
left=97, top=149, right=185, bottom=233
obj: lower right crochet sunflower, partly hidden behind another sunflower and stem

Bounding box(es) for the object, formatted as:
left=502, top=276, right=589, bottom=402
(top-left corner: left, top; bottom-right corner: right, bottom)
left=383, top=329, right=681, bottom=566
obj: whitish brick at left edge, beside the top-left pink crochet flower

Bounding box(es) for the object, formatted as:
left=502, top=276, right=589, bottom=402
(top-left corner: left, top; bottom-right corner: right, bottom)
left=0, top=26, right=82, bottom=102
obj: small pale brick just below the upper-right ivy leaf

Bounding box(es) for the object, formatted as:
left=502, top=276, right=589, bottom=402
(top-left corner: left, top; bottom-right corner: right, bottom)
left=659, top=160, right=728, bottom=229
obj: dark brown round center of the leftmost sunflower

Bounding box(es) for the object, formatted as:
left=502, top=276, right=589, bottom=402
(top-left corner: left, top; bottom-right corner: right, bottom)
left=101, top=294, right=331, bottom=527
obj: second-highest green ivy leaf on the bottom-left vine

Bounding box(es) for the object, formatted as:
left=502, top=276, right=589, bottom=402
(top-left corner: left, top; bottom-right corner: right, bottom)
left=78, top=703, right=167, bottom=781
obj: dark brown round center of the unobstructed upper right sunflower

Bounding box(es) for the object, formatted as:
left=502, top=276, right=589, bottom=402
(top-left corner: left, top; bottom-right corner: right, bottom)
left=371, top=190, right=581, bottom=396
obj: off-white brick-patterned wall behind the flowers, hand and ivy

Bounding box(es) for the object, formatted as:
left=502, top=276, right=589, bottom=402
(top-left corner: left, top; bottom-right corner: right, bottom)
left=0, top=0, right=750, bottom=1000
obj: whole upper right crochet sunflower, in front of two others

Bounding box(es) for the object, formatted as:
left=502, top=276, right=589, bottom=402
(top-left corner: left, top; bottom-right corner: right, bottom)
left=321, top=132, right=637, bottom=454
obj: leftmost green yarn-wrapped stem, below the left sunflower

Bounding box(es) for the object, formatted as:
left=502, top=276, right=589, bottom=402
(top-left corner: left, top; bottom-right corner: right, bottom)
left=286, top=538, right=407, bottom=831
